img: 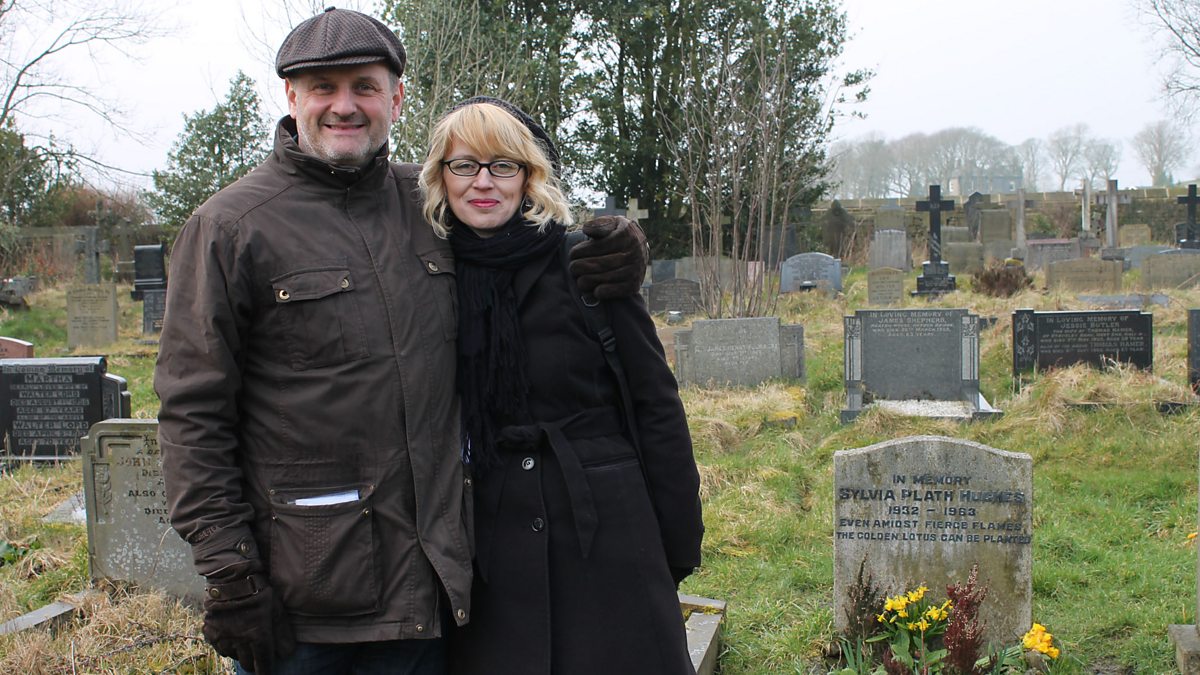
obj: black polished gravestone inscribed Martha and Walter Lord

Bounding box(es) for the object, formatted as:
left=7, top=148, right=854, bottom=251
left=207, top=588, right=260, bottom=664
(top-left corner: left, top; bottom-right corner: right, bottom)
left=0, top=357, right=131, bottom=461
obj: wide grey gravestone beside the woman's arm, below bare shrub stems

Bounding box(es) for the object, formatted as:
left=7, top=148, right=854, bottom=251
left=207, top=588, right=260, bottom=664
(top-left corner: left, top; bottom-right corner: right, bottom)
left=676, top=316, right=804, bottom=387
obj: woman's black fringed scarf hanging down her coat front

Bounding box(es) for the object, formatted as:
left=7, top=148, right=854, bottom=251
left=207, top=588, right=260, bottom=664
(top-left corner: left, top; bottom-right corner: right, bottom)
left=450, top=211, right=565, bottom=470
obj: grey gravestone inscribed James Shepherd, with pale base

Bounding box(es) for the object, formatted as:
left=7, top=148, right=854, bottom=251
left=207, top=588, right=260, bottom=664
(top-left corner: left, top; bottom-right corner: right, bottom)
left=841, top=309, right=1000, bottom=423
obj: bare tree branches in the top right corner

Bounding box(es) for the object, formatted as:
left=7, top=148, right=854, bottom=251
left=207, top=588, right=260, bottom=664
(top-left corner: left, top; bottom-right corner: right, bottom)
left=1140, top=0, right=1200, bottom=119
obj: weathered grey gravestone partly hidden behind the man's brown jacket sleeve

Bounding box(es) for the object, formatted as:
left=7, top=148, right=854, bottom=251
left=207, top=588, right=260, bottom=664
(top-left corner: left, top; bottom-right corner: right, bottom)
left=83, top=419, right=204, bottom=602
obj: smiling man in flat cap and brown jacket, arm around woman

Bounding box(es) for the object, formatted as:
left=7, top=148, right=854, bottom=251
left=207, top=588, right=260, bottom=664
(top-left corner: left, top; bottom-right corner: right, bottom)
left=155, top=8, right=646, bottom=674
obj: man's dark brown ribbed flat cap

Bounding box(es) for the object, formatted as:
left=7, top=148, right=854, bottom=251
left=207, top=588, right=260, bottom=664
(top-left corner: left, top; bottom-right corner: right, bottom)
left=275, top=7, right=407, bottom=77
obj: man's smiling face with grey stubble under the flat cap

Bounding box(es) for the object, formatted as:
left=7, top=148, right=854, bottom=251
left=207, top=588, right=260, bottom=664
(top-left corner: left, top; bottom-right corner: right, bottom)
left=283, top=62, right=404, bottom=166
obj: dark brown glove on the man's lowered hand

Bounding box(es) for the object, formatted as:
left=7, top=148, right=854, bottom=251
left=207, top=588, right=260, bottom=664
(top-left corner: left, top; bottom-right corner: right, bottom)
left=204, top=574, right=295, bottom=675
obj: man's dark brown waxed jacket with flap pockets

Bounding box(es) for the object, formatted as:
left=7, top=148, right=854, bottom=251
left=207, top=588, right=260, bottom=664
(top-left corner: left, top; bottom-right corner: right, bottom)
left=155, top=118, right=472, bottom=643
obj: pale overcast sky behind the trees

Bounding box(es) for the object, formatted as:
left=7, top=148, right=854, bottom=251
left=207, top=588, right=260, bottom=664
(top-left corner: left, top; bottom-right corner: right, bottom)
left=11, top=0, right=1200, bottom=194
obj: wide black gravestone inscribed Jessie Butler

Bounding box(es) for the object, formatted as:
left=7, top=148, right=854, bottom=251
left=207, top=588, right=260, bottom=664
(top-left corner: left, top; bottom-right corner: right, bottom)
left=1013, top=310, right=1154, bottom=381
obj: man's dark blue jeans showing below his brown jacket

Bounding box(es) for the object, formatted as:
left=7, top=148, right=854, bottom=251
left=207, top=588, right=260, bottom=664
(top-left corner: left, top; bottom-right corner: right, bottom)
left=234, top=638, right=446, bottom=675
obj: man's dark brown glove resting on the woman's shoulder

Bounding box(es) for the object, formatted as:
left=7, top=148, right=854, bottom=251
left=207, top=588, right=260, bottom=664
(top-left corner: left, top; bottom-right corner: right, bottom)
left=570, top=216, right=649, bottom=300
